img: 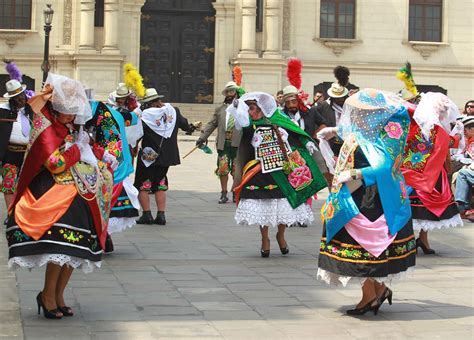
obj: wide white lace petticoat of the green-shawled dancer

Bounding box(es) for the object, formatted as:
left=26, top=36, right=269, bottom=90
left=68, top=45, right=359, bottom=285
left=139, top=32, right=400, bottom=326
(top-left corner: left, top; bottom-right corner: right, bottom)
left=235, top=198, right=314, bottom=227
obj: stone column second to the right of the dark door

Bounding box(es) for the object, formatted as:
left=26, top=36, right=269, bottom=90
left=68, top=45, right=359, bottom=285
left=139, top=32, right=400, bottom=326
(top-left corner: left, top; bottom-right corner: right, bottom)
left=263, top=0, right=281, bottom=58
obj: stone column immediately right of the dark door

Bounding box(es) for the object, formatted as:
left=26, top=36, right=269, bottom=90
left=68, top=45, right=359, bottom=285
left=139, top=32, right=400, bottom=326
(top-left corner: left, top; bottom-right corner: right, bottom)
left=239, top=0, right=258, bottom=58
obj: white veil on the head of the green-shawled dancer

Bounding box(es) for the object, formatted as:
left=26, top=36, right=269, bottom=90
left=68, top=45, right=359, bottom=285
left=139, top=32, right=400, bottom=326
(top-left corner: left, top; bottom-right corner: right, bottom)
left=226, top=92, right=277, bottom=129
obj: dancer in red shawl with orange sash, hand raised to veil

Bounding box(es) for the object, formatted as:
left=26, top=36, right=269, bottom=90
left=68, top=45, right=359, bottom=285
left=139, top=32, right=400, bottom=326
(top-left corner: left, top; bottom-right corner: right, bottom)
left=6, top=73, right=113, bottom=319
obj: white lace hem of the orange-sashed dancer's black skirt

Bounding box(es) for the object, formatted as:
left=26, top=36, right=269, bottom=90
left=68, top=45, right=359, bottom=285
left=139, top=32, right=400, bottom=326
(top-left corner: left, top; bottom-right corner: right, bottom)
left=8, top=254, right=101, bottom=274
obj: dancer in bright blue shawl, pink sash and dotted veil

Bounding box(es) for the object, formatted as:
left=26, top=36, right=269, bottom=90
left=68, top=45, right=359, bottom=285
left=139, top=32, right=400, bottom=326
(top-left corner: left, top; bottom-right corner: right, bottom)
left=318, top=89, right=416, bottom=315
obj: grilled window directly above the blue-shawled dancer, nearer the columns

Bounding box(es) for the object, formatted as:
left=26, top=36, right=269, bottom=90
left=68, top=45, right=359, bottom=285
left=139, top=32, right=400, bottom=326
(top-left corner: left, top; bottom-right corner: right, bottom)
left=319, top=0, right=355, bottom=39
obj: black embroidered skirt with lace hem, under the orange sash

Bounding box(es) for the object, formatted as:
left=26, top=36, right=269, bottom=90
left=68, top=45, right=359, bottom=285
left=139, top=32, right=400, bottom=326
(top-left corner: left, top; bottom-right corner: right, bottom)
left=6, top=170, right=103, bottom=272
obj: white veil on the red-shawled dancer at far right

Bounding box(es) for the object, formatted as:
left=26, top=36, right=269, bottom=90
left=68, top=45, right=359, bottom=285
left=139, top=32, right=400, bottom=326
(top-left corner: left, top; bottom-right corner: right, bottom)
left=413, top=92, right=461, bottom=138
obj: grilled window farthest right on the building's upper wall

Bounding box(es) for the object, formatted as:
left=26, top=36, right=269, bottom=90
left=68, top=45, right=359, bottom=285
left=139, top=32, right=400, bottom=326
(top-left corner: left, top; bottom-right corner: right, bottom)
left=409, top=0, right=443, bottom=42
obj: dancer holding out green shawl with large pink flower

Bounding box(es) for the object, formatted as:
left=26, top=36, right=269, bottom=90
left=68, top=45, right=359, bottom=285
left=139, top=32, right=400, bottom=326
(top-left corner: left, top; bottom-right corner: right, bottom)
left=227, top=92, right=327, bottom=257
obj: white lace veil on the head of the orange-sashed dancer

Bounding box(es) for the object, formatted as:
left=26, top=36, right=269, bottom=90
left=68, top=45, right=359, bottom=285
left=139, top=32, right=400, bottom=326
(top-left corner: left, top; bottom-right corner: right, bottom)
left=46, top=73, right=92, bottom=125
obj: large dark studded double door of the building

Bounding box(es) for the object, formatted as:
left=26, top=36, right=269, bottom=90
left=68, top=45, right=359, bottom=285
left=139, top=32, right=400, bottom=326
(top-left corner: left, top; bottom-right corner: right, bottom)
left=140, top=0, right=215, bottom=104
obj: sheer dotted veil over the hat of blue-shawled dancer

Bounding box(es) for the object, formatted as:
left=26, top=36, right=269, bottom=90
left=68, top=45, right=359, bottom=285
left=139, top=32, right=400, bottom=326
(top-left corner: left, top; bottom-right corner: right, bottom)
left=338, top=89, right=402, bottom=144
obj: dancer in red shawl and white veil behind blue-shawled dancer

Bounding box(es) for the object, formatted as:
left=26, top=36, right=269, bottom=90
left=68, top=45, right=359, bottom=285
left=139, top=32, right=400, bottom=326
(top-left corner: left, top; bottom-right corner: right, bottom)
left=402, top=92, right=463, bottom=254
